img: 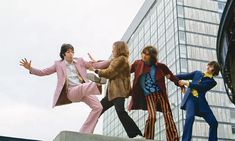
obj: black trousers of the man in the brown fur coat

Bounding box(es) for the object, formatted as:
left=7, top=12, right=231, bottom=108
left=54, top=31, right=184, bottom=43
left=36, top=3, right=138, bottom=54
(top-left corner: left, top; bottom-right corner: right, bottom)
left=101, top=96, right=142, bottom=138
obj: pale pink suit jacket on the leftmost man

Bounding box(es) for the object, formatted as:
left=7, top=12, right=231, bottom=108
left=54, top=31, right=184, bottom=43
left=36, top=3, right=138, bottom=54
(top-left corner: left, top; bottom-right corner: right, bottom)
left=30, top=58, right=110, bottom=107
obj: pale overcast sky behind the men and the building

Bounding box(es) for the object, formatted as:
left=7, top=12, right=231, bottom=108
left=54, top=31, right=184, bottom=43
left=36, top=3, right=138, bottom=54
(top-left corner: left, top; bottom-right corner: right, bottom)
left=0, top=0, right=144, bottom=141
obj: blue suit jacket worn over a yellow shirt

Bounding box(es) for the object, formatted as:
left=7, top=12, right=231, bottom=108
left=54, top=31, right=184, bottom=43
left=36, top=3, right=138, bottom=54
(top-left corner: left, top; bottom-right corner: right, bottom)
left=176, top=71, right=217, bottom=113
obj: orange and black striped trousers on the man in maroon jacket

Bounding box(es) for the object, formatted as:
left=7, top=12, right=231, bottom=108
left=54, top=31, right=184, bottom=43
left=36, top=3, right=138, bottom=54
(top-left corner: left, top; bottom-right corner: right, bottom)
left=144, top=93, right=179, bottom=141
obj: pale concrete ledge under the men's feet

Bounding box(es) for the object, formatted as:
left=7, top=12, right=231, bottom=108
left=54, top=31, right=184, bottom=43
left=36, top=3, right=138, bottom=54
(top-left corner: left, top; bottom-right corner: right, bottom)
left=53, top=131, right=151, bottom=141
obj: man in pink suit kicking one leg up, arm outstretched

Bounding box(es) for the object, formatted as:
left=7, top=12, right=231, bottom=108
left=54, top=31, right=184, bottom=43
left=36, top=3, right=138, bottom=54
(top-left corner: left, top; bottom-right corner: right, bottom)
left=20, top=44, right=109, bottom=133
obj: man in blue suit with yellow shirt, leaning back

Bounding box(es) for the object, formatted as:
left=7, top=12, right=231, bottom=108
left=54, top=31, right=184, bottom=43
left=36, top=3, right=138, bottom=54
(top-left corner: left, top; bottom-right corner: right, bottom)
left=176, top=61, right=220, bottom=141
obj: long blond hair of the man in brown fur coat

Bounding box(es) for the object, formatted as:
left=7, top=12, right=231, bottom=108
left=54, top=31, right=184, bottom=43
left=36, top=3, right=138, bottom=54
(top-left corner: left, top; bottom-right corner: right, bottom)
left=113, top=41, right=129, bottom=57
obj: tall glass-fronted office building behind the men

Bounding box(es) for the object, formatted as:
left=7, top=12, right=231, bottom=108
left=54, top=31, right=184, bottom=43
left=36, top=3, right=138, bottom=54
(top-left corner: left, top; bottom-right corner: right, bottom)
left=103, top=0, right=235, bottom=141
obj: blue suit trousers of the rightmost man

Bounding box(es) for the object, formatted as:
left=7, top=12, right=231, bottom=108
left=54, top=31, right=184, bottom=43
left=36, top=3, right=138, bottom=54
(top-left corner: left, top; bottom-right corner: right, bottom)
left=182, top=95, right=218, bottom=141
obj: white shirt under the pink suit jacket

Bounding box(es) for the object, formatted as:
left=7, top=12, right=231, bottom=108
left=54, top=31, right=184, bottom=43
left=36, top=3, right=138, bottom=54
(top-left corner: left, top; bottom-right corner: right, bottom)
left=64, top=60, right=81, bottom=87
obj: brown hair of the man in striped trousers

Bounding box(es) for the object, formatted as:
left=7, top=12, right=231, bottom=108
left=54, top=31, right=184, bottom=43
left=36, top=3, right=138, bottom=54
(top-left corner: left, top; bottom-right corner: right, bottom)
left=142, top=45, right=158, bottom=64
